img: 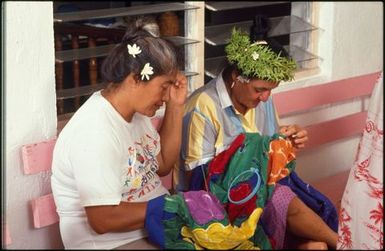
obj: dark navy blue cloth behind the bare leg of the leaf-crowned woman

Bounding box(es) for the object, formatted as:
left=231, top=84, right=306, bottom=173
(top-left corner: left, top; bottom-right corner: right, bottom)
left=278, top=172, right=338, bottom=232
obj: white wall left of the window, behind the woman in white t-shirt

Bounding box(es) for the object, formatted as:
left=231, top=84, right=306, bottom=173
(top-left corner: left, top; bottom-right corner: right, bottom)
left=2, top=1, right=61, bottom=249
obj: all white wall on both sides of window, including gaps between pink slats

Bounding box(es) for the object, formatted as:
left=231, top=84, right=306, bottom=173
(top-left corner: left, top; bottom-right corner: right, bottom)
left=2, top=2, right=383, bottom=249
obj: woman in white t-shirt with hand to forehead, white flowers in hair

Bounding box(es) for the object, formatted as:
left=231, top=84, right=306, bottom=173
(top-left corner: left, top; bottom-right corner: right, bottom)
left=51, top=18, right=187, bottom=249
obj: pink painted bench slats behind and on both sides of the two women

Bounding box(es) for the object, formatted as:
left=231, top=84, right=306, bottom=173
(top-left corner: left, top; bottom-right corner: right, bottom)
left=16, top=73, right=379, bottom=249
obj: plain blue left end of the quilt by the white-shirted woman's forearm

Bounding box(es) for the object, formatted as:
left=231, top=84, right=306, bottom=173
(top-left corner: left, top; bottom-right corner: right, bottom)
left=144, top=195, right=166, bottom=249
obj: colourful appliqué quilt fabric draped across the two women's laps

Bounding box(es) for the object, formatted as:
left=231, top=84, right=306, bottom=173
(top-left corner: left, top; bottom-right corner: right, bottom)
left=145, top=133, right=295, bottom=249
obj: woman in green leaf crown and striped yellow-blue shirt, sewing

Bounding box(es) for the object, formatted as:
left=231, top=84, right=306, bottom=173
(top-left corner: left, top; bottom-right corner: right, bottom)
left=177, top=16, right=337, bottom=249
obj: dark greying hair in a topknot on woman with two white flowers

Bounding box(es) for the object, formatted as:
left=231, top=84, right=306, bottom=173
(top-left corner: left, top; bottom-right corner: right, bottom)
left=101, top=17, right=180, bottom=83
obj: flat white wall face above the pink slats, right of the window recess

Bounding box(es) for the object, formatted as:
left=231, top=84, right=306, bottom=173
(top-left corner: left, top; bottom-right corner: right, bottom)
left=328, top=2, right=384, bottom=79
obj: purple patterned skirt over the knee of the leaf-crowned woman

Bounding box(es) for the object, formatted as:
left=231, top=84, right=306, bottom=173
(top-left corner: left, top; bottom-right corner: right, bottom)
left=261, top=183, right=296, bottom=249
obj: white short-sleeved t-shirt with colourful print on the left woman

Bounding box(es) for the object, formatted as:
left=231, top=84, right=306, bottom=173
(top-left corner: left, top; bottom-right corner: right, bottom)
left=51, top=91, right=168, bottom=249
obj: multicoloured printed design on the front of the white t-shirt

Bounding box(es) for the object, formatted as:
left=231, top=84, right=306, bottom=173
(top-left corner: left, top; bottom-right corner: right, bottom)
left=122, top=134, right=161, bottom=201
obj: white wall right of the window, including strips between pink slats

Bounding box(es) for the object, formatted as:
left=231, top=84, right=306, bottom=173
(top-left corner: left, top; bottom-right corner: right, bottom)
left=274, top=2, right=383, bottom=181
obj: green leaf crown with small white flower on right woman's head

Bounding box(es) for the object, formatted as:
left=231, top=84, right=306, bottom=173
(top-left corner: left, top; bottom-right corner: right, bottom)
left=225, top=28, right=297, bottom=82
